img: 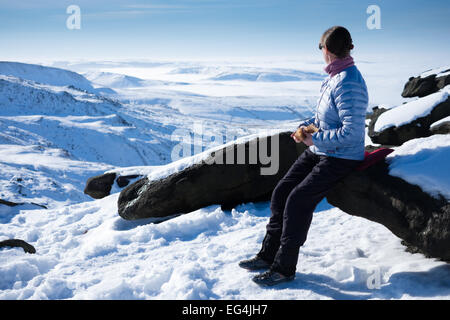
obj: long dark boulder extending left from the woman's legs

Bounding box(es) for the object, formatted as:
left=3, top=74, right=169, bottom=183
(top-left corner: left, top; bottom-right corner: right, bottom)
left=118, top=132, right=306, bottom=220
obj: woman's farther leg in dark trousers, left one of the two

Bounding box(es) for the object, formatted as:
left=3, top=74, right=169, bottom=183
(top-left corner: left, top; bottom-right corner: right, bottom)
left=257, top=149, right=319, bottom=263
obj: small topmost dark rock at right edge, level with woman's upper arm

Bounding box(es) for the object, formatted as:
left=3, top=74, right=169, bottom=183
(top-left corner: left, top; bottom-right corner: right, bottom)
left=402, top=69, right=450, bottom=98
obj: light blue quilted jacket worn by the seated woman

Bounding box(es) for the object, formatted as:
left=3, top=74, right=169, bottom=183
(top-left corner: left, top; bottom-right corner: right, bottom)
left=299, top=66, right=369, bottom=160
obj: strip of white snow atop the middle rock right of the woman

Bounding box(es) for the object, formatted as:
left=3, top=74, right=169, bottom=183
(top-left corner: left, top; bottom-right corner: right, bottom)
left=374, top=86, right=450, bottom=132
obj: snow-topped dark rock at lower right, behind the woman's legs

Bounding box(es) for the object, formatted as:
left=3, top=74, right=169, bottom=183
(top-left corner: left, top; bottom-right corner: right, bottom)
left=327, top=141, right=450, bottom=261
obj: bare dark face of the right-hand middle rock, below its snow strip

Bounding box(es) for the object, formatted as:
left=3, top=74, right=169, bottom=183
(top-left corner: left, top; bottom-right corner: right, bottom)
left=369, top=98, right=450, bottom=146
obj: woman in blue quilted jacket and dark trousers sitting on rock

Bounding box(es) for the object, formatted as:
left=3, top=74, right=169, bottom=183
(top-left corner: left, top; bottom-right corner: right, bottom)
left=239, top=26, right=368, bottom=286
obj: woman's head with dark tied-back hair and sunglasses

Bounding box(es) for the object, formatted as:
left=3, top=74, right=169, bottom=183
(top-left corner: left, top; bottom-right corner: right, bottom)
left=319, top=26, right=353, bottom=63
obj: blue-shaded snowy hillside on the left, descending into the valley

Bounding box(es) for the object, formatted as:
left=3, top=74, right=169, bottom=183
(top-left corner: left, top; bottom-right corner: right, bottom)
left=0, top=72, right=181, bottom=166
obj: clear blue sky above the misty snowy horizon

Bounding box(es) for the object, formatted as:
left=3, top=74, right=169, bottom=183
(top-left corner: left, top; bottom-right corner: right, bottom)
left=0, top=0, right=450, bottom=60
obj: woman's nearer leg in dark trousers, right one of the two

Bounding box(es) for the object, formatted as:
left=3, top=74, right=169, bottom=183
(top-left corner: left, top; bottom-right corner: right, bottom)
left=272, top=156, right=361, bottom=276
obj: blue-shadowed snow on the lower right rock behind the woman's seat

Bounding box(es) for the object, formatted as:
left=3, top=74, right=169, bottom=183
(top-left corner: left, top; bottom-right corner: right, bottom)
left=388, top=134, right=450, bottom=200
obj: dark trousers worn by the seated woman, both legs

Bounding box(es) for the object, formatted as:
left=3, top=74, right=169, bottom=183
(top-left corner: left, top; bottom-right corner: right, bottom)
left=257, top=149, right=361, bottom=275
